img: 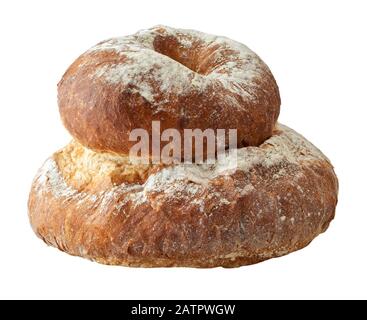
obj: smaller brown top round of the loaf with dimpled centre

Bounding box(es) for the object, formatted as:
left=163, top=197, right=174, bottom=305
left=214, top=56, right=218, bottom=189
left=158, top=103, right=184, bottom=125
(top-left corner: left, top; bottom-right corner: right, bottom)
left=58, top=26, right=280, bottom=154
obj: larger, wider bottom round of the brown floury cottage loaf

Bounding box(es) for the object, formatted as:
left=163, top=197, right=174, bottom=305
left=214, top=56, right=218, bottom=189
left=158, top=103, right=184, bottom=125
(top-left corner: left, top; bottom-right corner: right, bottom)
left=29, top=125, right=338, bottom=267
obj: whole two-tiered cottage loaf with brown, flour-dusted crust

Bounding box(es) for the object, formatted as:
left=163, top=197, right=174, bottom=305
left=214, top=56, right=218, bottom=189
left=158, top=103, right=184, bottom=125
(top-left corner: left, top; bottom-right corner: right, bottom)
left=28, top=27, right=338, bottom=267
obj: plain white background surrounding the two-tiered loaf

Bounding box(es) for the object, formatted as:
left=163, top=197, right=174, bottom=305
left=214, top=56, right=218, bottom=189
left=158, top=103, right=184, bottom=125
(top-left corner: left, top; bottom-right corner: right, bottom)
left=0, top=0, right=367, bottom=299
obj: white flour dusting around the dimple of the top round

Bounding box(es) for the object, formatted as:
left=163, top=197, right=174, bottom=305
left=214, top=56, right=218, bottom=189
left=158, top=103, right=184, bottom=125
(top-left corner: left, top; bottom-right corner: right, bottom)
left=87, top=26, right=267, bottom=107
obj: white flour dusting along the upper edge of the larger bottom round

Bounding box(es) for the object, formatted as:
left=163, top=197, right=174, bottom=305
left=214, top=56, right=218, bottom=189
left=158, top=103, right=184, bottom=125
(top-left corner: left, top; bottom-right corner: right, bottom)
left=36, top=125, right=328, bottom=211
